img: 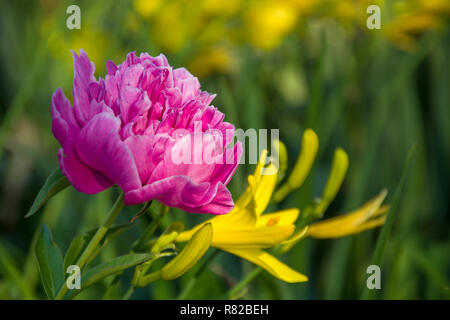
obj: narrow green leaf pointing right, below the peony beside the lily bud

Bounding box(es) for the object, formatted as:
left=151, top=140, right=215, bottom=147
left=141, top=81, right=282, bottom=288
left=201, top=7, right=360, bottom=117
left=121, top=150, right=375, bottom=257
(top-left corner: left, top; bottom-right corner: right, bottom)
left=71, top=253, right=153, bottom=297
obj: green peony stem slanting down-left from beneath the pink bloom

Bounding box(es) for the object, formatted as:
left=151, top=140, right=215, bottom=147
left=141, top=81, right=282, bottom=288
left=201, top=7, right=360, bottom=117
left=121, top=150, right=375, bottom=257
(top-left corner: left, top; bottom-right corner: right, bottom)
left=55, top=192, right=124, bottom=300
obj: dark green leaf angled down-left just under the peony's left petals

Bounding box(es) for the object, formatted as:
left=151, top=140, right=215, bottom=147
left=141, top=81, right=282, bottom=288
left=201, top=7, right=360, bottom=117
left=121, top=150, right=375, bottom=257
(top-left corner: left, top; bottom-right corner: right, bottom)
left=25, top=168, right=70, bottom=218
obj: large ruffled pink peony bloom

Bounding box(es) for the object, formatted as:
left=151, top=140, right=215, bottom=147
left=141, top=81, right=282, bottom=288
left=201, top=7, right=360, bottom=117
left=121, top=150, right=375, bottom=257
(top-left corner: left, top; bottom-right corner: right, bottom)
left=52, top=50, right=242, bottom=214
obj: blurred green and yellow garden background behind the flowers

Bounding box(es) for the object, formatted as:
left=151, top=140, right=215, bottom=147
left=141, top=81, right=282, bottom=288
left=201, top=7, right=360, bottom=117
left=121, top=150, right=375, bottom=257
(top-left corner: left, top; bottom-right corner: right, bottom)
left=0, top=0, right=450, bottom=299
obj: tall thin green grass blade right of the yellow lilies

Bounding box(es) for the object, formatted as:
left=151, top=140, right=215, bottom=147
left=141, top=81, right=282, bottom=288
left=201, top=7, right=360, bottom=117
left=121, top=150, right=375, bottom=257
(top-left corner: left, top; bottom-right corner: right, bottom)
left=361, top=145, right=416, bottom=299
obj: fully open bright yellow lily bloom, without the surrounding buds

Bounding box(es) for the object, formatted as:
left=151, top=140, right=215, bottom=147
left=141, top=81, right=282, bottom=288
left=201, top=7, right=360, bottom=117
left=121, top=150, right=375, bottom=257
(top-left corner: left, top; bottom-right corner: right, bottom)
left=176, top=151, right=308, bottom=282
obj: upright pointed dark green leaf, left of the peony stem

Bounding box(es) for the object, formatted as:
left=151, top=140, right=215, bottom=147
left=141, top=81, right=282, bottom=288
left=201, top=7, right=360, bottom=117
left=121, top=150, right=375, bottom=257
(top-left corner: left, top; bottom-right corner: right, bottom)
left=34, top=224, right=64, bottom=299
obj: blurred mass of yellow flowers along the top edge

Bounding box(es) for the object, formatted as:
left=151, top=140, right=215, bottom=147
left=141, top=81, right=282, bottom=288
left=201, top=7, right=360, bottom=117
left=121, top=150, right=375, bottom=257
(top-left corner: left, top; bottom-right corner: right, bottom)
left=132, top=0, right=450, bottom=74
